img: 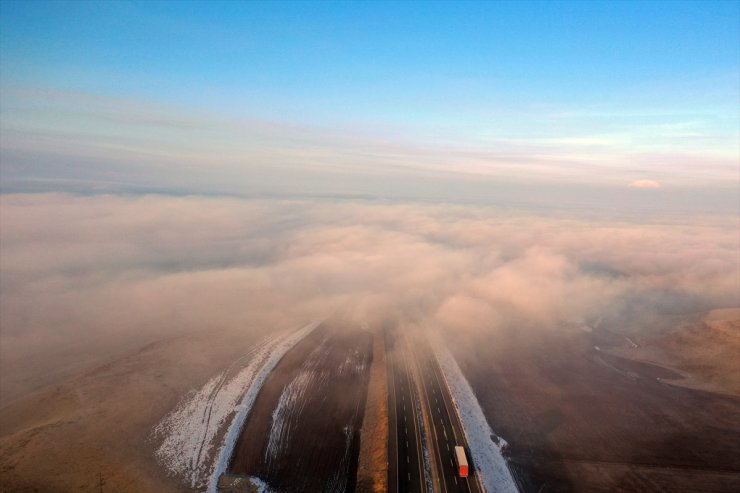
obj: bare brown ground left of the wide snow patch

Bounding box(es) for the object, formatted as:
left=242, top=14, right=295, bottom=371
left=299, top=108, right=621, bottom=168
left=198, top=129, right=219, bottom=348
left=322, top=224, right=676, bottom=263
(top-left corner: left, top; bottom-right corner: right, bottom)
left=0, top=331, right=266, bottom=493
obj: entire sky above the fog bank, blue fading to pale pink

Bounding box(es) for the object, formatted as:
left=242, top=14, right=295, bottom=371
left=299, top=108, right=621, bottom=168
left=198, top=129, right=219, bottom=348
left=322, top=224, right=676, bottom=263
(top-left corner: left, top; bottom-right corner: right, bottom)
left=0, top=1, right=740, bottom=212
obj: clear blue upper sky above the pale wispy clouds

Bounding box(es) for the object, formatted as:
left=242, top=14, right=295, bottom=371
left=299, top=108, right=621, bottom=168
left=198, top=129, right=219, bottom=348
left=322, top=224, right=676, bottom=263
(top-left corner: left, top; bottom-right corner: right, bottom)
left=2, top=1, right=740, bottom=114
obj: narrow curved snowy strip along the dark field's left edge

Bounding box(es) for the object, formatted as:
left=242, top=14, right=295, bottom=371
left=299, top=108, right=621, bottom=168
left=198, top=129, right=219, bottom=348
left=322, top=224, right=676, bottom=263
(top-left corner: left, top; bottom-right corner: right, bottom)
left=208, top=321, right=321, bottom=493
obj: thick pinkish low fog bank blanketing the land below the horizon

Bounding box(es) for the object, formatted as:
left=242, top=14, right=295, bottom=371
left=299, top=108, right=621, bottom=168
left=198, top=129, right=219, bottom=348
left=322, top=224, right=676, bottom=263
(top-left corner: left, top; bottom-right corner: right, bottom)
left=0, top=190, right=740, bottom=402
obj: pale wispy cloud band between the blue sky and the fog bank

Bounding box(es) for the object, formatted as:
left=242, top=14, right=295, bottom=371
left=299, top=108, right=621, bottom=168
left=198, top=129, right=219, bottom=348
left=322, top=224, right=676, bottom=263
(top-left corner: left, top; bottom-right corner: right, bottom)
left=0, top=87, right=740, bottom=211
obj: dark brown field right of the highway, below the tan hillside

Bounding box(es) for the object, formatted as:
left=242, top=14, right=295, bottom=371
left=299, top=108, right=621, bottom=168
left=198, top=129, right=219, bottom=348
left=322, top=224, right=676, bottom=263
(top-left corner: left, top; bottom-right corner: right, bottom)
left=446, top=314, right=740, bottom=493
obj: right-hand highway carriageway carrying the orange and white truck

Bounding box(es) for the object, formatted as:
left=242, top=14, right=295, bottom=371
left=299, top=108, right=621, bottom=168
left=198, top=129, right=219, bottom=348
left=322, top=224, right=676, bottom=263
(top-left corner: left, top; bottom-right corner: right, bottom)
left=414, top=341, right=482, bottom=493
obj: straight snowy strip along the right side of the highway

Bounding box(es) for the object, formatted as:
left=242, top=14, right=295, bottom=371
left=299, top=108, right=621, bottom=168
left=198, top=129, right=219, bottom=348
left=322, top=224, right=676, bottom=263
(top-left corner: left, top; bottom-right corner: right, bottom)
left=433, top=341, right=518, bottom=493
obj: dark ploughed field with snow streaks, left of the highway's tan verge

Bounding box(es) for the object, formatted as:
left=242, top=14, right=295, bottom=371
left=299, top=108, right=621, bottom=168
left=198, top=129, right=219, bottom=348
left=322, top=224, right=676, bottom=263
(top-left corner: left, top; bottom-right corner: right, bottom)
left=229, top=322, right=372, bottom=493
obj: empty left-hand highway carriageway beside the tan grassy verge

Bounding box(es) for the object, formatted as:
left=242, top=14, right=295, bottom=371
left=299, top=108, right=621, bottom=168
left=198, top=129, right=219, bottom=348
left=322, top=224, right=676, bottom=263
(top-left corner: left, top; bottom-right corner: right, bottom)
left=385, top=330, right=426, bottom=493
